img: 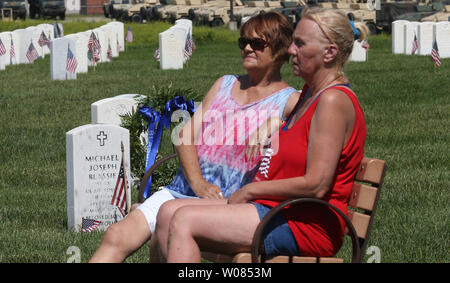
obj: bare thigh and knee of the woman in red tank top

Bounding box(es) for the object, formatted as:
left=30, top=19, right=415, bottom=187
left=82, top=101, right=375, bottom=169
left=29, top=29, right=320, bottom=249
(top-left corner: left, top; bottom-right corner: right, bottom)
left=167, top=203, right=260, bottom=262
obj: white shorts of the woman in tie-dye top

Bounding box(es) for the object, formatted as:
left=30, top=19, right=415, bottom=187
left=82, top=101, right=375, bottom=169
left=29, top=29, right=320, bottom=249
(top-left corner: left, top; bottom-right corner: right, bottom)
left=137, top=187, right=175, bottom=234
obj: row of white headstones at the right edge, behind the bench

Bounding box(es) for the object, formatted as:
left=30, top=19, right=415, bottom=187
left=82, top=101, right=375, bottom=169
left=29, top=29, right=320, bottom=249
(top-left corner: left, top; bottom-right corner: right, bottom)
left=392, top=20, right=450, bottom=58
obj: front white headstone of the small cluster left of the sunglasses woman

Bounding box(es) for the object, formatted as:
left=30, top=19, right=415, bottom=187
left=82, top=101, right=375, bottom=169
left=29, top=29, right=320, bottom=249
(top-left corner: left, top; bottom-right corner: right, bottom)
left=159, top=29, right=186, bottom=70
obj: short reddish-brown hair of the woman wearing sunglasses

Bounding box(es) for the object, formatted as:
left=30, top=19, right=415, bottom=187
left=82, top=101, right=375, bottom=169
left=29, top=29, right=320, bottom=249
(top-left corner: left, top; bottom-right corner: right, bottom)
left=241, top=12, right=294, bottom=63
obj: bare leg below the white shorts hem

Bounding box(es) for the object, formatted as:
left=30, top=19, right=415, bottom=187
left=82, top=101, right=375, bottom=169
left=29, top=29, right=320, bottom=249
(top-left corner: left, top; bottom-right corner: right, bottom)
left=89, top=209, right=151, bottom=262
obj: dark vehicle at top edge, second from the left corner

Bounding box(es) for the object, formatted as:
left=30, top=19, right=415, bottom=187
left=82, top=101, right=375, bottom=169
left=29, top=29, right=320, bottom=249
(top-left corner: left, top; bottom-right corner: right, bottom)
left=28, top=0, right=66, bottom=20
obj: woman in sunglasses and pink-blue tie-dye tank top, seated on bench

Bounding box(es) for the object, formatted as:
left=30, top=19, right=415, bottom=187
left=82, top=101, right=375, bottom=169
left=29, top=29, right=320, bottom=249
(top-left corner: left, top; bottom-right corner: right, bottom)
left=91, top=12, right=299, bottom=262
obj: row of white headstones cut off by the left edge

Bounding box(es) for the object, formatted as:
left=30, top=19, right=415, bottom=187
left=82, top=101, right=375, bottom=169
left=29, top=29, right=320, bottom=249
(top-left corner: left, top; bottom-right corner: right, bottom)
left=0, top=23, right=60, bottom=70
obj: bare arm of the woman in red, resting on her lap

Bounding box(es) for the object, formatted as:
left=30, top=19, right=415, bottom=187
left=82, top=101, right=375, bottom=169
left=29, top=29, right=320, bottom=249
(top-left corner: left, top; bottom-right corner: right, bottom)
left=228, top=89, right=355, bottom=203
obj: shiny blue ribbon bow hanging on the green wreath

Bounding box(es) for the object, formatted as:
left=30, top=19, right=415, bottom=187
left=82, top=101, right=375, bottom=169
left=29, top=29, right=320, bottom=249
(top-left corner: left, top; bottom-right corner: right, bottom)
left=139, top=96, right=195, bottom=199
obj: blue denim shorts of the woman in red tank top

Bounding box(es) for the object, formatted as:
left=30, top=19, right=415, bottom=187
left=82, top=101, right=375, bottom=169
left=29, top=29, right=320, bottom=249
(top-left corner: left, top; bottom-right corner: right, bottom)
left=252, top=202, right=300, bottom=257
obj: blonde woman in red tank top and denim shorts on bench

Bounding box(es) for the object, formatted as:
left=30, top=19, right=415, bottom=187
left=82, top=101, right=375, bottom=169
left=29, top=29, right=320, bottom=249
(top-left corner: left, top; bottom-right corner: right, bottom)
left=160, top=9, right=367, bottom=262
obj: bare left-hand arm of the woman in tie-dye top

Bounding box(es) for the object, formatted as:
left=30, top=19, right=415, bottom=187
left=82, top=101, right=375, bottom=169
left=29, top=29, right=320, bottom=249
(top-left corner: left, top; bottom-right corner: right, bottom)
left=175, top=79, right=227, bottom=198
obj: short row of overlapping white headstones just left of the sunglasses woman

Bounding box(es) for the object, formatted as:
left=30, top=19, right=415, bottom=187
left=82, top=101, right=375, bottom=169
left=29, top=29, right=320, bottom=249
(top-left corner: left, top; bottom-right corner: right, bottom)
left=155, top=19, right=192, bottom=70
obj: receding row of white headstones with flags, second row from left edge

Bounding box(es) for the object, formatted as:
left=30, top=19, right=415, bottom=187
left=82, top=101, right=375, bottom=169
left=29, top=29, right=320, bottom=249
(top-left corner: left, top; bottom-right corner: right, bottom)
left=50, top=21, right=125, bottom=80
